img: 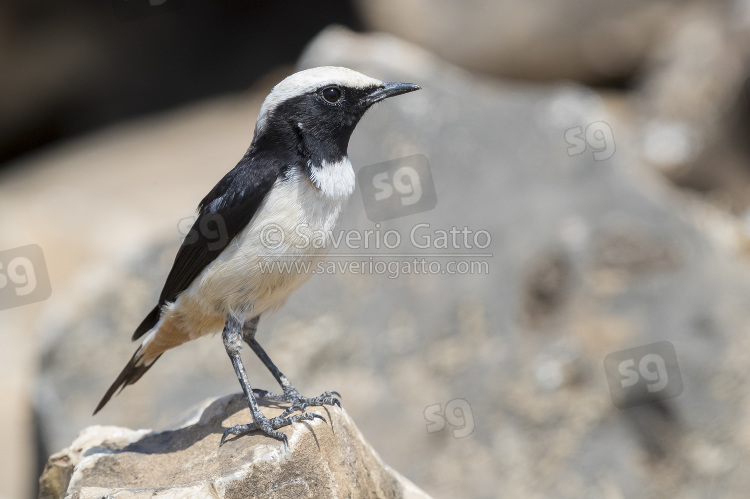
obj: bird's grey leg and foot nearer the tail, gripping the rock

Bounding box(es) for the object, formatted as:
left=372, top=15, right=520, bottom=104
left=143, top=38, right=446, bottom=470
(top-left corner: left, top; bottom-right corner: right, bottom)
left=219, top=316, right=323, bottom=446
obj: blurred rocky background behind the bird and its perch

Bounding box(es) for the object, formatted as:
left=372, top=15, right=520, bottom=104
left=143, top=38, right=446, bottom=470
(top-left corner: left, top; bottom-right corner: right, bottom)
left=0, top=0, right=750, bottom=498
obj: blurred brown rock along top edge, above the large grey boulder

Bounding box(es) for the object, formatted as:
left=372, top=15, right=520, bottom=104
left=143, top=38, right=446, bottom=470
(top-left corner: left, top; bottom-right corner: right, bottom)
left=356, top=0, right=730, bottom=83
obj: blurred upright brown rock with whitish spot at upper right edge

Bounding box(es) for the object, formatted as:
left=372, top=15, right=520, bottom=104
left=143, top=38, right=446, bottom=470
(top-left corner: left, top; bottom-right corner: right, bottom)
left=632, top=1, right=750, bottom=214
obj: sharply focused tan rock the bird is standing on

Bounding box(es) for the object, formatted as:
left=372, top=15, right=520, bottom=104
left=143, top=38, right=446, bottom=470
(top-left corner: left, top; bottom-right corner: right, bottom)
left=39, top=394, right=429, bottom=499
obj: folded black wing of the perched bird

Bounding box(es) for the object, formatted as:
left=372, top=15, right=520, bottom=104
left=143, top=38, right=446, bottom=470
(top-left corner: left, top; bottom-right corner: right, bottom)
left=133, top=157, right=285, bottom=340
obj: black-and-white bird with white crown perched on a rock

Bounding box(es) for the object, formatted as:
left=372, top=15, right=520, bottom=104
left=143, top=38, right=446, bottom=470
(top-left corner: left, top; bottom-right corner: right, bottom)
left=94, top=66, right=421, bottom=445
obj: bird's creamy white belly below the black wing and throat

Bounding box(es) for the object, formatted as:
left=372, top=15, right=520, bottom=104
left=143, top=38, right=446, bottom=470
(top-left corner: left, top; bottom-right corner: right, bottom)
left=180, top=166, right=353, bottom=334
